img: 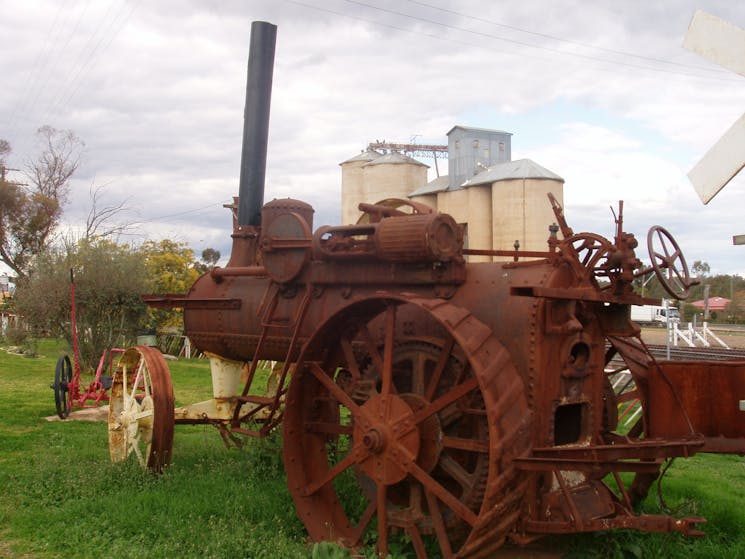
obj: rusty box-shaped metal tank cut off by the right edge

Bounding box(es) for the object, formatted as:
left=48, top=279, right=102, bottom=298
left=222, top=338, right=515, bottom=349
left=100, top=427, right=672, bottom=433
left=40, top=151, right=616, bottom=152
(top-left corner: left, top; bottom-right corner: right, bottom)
left=649, top=361, right=745, bottom=454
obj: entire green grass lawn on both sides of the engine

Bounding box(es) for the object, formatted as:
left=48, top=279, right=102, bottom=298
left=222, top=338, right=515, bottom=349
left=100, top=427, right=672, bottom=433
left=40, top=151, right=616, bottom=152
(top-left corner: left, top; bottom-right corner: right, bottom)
left=0, top=340, right=745, bottom=559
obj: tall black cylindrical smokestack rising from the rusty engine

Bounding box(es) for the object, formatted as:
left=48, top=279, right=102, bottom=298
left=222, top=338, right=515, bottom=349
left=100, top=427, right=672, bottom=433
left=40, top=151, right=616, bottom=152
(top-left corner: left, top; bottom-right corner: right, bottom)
left=238, top=21, right=277, bottom=226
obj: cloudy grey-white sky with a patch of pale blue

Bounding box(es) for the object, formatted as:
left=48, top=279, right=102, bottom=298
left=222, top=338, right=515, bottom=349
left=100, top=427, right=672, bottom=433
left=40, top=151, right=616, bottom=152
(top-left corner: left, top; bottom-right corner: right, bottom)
left=0, top=0, right=745, bottom=275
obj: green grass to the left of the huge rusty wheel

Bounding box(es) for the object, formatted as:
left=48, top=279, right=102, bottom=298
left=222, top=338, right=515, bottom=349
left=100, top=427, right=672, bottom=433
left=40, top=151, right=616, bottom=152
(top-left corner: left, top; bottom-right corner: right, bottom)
left=0, top=341, right=311, bottom=558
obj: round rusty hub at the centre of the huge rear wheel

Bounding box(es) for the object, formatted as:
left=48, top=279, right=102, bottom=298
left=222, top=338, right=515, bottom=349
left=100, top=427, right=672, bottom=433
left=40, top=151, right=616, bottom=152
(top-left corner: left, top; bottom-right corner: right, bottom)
left=353, top=394, right=420, bottom=485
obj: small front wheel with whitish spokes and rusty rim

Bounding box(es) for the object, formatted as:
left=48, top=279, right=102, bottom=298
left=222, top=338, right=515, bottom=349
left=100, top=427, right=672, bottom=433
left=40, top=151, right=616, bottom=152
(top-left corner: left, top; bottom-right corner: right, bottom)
left=109, top=346, right=174, bottom=472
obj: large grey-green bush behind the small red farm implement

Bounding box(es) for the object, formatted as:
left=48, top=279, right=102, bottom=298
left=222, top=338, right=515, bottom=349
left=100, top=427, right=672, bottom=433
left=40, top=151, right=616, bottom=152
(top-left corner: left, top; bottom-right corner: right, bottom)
left=15, top=239, right=146, bottom=368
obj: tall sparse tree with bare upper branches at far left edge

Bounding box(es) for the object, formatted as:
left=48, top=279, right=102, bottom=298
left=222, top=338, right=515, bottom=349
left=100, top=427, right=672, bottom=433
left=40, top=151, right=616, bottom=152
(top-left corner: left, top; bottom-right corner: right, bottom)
left=0, top=130, right=84, bottom=279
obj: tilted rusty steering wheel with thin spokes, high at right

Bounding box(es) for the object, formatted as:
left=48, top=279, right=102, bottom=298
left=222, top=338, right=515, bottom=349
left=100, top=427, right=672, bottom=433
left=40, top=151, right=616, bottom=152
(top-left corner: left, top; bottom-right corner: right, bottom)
left=647, top=225, right=698, bottom=299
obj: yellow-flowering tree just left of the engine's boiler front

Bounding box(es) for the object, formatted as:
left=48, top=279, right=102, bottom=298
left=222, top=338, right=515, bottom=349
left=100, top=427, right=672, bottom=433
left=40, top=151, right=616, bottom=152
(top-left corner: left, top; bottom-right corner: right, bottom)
left=140, top=239, right=200, bottom=330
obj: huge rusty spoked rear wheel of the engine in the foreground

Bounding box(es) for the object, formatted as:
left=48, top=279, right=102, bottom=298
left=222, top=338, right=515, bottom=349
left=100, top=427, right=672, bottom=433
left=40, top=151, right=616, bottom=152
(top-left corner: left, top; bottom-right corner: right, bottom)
left=284, top=298, right=530, bottom=558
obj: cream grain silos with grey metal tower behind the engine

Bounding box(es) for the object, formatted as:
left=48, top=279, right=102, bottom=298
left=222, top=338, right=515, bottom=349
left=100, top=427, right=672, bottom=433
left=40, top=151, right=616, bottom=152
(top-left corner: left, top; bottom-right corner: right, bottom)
left=340, top=126, right=564, bottom=261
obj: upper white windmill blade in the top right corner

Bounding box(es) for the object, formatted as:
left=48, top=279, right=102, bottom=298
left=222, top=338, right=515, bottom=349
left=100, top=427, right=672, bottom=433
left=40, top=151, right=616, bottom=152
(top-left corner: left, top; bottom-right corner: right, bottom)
left=683, top=10, right=745, bottom=76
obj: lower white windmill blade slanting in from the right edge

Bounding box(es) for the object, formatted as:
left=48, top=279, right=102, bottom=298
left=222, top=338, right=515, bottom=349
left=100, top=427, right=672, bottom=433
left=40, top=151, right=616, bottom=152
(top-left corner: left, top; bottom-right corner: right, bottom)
left=688, top=114, right=745, bottom=204
